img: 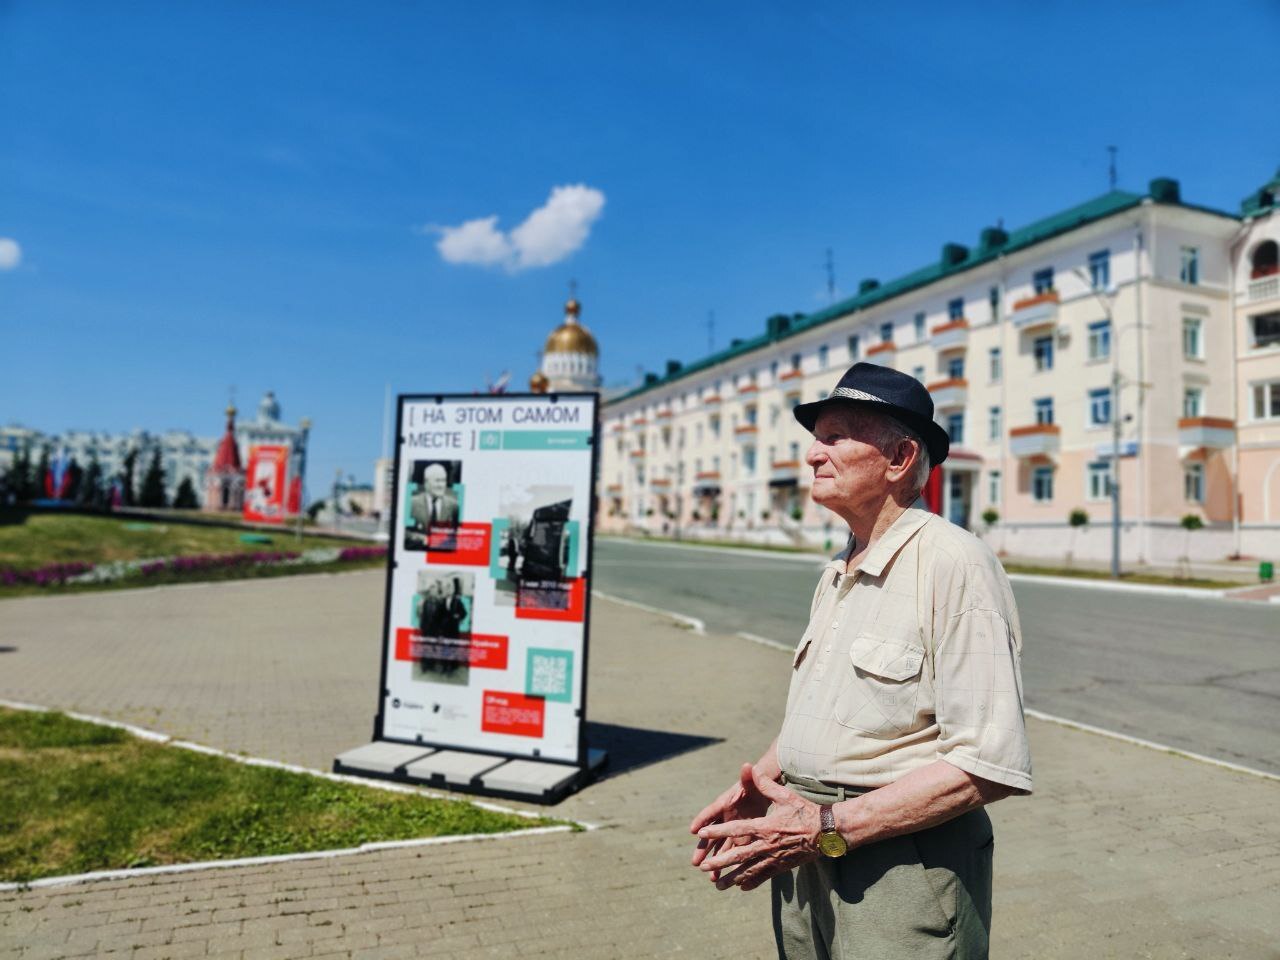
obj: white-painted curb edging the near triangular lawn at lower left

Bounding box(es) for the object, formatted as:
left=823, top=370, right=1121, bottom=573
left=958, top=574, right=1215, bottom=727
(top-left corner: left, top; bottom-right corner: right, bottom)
left=0, top=699, right=599, bottom=891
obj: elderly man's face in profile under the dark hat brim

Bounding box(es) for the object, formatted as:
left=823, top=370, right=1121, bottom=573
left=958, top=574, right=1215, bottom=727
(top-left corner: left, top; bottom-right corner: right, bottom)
left=805, top=407, right=890, bottom=515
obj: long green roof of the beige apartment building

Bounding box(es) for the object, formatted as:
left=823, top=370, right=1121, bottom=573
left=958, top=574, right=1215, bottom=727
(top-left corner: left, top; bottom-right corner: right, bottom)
left=608, top=180, right=1238, bottom=404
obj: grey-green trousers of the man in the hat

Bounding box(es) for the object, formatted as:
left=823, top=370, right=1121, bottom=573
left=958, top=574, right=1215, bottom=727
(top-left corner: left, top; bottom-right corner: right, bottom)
left=772, top=809, right=995, bottom=960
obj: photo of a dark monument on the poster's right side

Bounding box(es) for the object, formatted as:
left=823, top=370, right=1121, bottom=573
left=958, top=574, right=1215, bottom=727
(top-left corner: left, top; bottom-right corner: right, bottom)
left=495, top=484, right=573, bottom=609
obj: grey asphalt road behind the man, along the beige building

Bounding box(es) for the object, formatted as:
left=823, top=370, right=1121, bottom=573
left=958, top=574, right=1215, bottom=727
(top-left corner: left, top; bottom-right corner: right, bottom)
left=594, top=539, right=1280, bottom=774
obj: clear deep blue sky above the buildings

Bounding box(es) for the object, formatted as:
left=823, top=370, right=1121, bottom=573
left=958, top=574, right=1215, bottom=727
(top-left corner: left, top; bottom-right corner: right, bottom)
left=0, top=0, right=1280, bottom=489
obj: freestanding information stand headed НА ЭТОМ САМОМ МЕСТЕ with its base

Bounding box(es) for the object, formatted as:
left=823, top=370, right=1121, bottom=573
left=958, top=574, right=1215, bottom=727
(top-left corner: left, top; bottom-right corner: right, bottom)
left=333, top=393, right=605, bottom=803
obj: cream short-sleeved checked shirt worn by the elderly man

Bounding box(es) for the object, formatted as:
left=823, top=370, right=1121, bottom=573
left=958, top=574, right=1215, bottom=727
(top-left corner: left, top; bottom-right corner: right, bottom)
left=778, top=499, right=1032, bottom=792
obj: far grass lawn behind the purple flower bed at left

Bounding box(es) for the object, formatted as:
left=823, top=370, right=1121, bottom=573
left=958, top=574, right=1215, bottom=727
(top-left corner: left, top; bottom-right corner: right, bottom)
left=0, top=509, right=358, bottom=570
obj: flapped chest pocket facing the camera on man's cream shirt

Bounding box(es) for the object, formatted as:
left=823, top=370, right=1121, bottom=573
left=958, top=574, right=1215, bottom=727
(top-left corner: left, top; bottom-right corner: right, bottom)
left=835, top=634, right=924, bottom=740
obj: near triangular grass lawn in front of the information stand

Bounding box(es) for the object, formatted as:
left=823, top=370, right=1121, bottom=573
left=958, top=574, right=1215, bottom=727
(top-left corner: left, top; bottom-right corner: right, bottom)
left=0, top=708, right=559, bottom=882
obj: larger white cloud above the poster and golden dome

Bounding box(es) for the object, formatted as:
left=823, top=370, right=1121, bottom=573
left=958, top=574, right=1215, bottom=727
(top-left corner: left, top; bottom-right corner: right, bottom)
left=428, top=183, right=604, bottom=273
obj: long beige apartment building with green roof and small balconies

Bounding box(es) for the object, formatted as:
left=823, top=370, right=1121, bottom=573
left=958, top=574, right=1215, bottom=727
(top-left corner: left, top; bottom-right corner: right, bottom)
left=598, top=168, right=1280, bottom=563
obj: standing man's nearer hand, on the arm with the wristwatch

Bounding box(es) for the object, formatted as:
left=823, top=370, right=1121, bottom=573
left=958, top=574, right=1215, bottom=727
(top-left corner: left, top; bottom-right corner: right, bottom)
left=694, top=767, right=822, bottom=890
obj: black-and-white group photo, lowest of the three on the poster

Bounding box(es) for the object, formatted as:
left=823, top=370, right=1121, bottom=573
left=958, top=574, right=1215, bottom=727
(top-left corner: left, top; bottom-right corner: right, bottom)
left=411, top=570, right=476, bottom=686
